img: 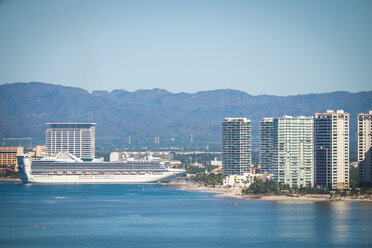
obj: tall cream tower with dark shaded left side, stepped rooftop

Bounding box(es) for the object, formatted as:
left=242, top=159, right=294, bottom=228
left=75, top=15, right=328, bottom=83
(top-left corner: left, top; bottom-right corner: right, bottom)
left=314, top=110, right=349, bottom=189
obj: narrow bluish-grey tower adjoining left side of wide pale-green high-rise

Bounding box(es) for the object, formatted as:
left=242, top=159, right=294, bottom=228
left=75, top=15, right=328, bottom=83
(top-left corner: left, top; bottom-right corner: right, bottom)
left=260, top=118, right=275, bottom=174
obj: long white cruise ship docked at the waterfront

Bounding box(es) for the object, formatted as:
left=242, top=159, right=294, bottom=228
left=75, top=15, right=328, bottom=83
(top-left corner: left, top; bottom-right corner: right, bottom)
left=17, top=152, right=186, bottom=183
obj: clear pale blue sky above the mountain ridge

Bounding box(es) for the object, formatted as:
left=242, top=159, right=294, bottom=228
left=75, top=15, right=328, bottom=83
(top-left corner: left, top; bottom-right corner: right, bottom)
left=0, top=0, right=372, bottom=95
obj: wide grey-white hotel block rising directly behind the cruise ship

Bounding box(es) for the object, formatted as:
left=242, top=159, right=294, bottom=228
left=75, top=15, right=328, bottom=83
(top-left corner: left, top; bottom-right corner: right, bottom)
left=46, top=123, right=96, bottom=160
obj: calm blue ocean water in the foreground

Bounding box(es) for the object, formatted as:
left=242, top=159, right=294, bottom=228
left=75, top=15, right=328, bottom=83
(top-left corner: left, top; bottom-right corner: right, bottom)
left=0, top=184, right=372, bottom=248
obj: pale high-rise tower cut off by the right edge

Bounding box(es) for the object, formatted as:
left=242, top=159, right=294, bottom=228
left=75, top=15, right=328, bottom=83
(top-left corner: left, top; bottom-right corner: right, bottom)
left=358, top=110, right=372, bottom=183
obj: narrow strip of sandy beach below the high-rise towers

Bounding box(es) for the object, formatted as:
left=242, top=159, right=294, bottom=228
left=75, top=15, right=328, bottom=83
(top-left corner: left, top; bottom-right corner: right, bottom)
left=178, top=183, right=372, bottom=202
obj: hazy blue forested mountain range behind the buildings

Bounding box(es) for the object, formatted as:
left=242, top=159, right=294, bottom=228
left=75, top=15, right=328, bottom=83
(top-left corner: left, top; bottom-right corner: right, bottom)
left=0, top=82, right=372, bottom=155
